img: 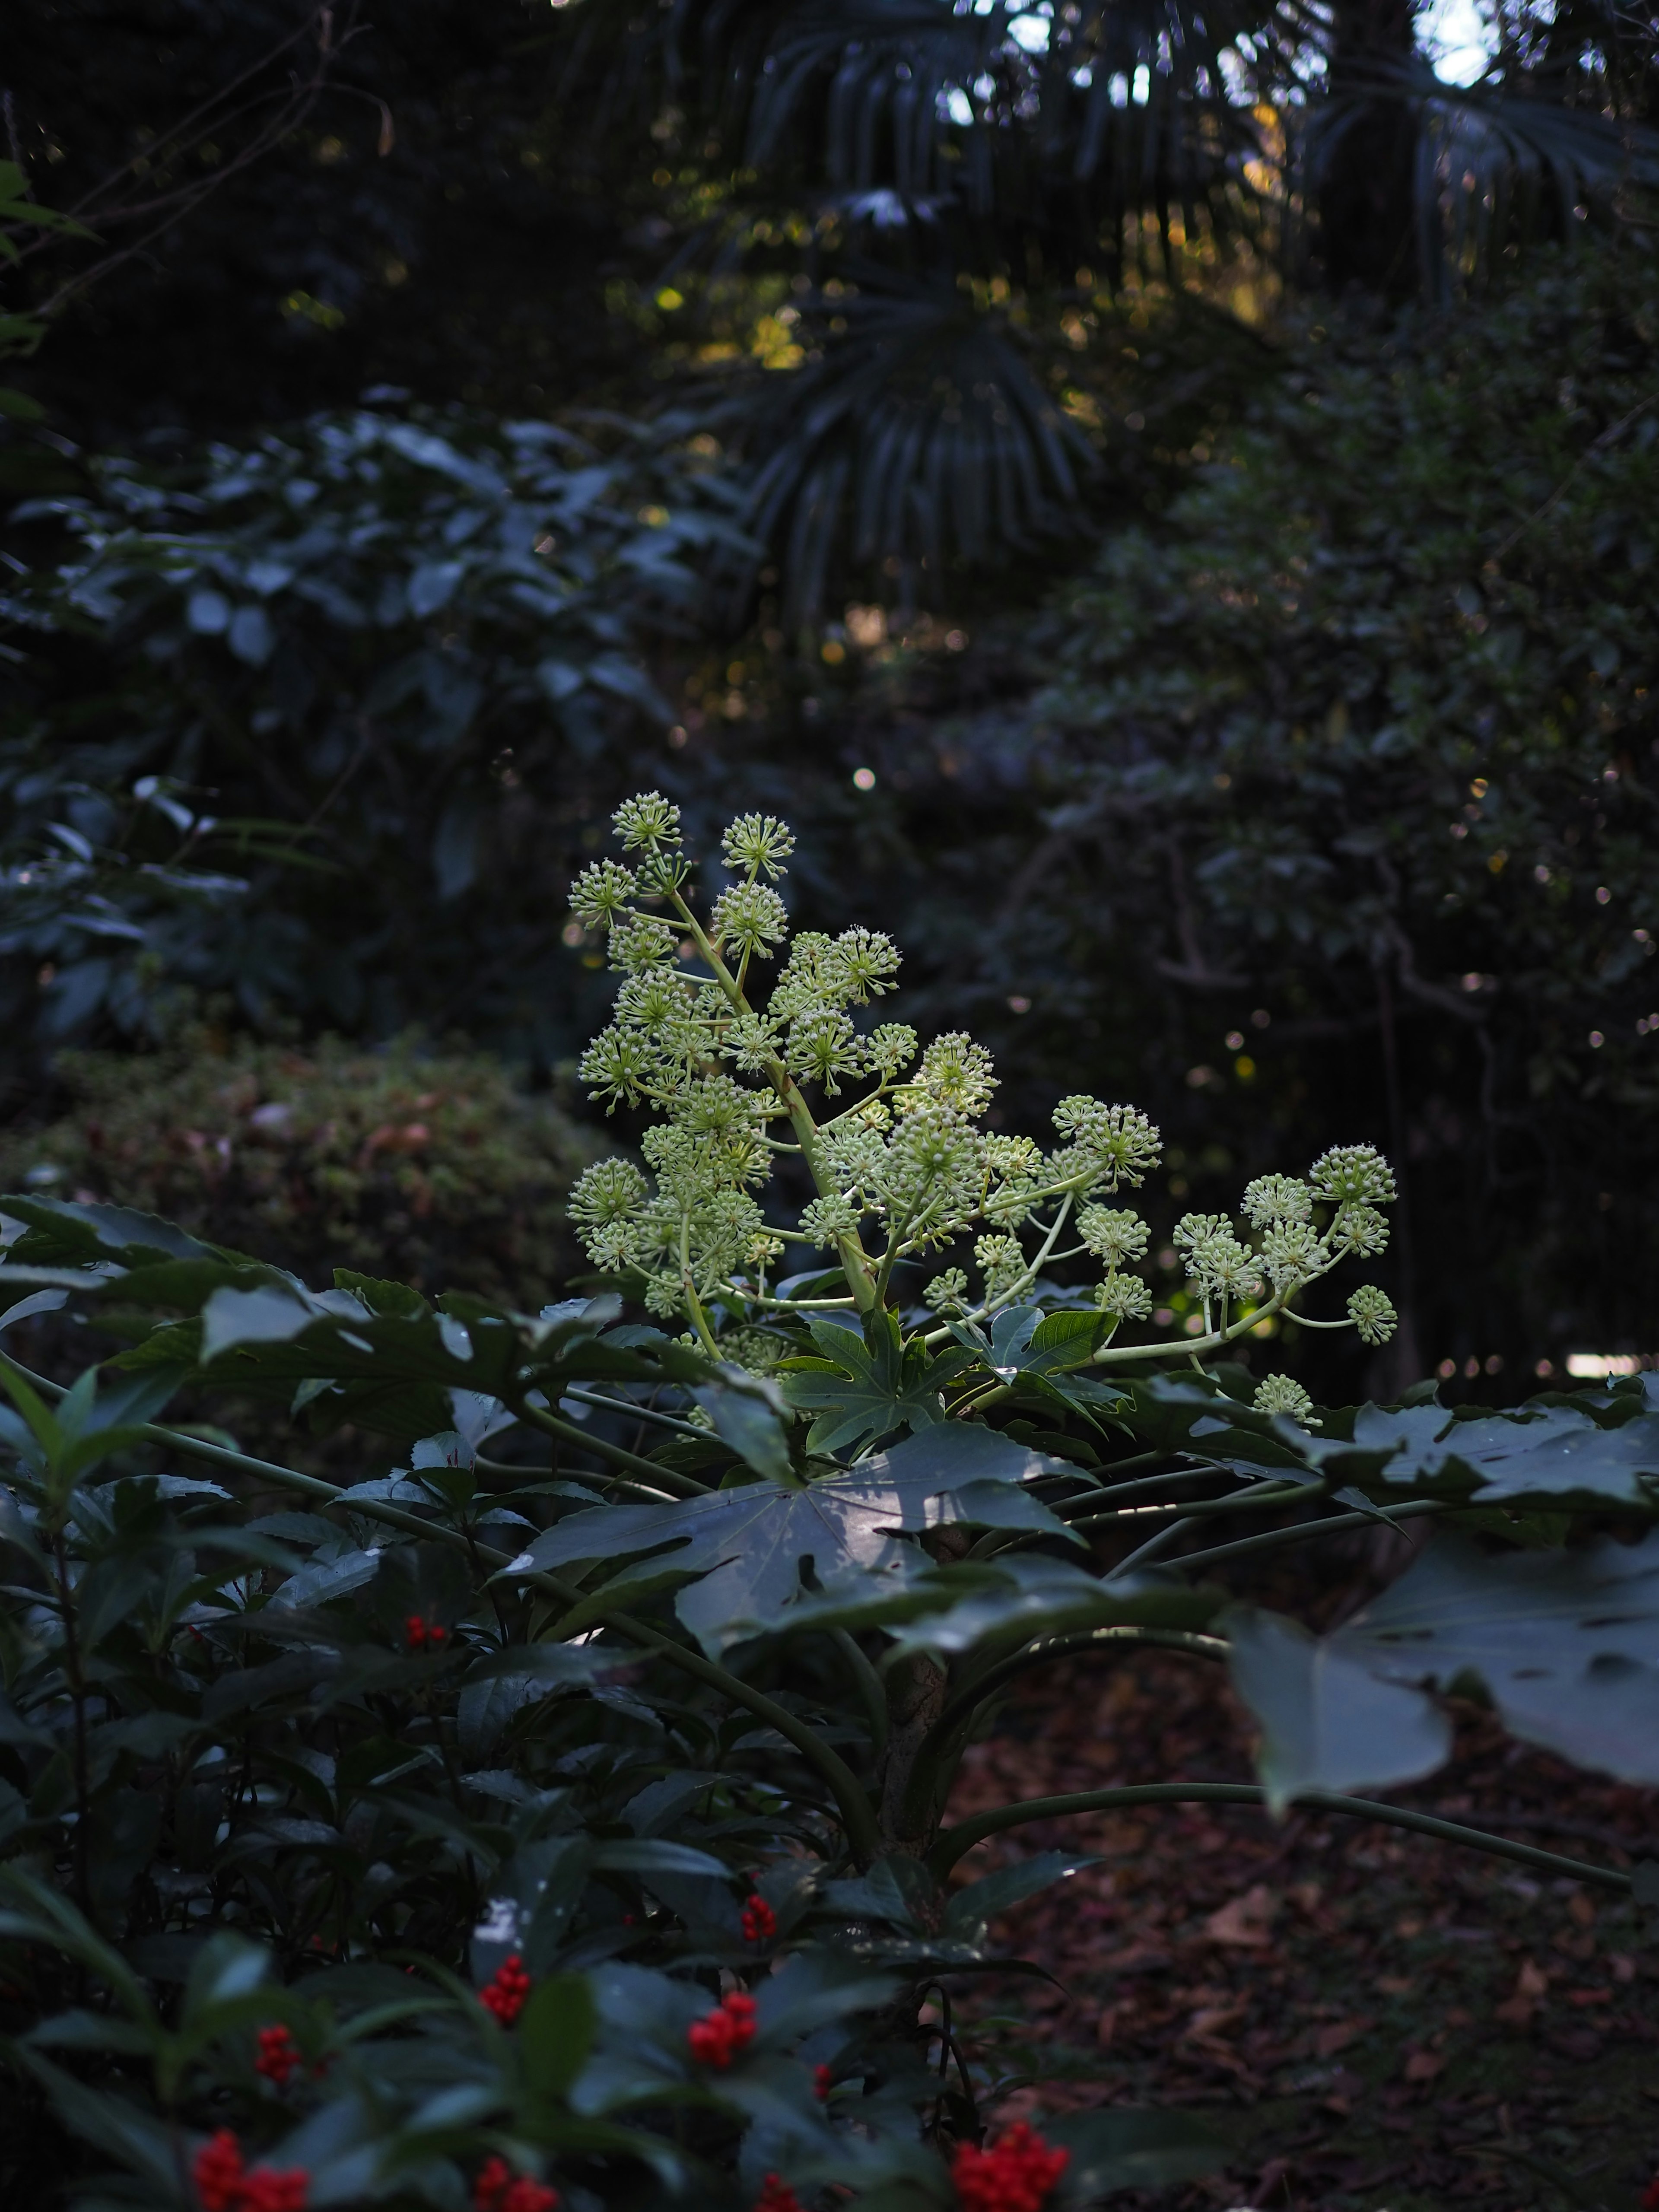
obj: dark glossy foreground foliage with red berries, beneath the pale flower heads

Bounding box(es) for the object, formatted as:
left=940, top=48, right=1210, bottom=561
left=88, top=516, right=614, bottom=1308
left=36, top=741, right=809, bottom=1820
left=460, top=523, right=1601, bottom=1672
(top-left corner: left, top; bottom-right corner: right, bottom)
left=0, top=1195, right=1659, bottom=2212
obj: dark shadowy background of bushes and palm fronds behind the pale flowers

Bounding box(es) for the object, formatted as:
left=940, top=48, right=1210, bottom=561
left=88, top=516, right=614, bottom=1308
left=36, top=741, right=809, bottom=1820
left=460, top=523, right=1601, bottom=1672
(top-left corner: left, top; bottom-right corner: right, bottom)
left=0, top=0, right=1659, bottom=1398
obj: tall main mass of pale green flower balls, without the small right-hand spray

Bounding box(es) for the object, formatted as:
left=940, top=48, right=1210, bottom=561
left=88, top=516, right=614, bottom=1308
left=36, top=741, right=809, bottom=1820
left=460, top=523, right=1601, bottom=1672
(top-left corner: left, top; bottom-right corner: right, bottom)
left=571, top=792, right=1159, bottom=1321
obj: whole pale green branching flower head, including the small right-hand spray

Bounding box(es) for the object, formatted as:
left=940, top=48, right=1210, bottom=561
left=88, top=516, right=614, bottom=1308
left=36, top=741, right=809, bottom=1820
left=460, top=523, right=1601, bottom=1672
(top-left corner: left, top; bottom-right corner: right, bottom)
left=571, top=792, right=1396, bottom=1371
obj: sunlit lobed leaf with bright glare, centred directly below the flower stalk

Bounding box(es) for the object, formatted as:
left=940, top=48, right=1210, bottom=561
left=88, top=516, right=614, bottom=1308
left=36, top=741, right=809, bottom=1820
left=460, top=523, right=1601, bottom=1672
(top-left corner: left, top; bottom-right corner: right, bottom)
left=504, top=1422, right=1077, bottom=1653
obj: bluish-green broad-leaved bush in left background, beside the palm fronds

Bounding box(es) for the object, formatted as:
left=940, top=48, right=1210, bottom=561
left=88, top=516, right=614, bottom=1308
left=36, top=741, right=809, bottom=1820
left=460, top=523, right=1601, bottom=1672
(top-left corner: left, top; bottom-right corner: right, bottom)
left=0, top=409, right=734, bottom=1079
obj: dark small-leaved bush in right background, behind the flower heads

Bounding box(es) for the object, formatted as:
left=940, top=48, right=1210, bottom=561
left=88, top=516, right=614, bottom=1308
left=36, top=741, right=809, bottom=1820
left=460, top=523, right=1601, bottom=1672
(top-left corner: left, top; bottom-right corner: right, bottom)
left=845, top=259, right=1659, bottom=1391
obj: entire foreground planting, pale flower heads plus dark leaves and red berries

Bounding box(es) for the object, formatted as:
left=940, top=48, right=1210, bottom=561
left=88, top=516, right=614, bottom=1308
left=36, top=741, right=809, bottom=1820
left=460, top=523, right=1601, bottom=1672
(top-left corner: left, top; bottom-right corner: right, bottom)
left=0, top=794, right=1659, bottom=2212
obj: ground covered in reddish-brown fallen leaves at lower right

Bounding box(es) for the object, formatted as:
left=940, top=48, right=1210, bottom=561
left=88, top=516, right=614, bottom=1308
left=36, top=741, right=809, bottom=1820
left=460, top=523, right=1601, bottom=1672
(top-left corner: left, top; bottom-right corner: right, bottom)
left=951, top=1650, right=1659, bottom=2212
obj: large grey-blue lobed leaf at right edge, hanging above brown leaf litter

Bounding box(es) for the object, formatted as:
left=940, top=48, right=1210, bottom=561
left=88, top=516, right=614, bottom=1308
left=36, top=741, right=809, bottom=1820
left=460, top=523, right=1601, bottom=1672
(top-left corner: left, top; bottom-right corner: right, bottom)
left=1228, top=1533, right=1659, bottom=1803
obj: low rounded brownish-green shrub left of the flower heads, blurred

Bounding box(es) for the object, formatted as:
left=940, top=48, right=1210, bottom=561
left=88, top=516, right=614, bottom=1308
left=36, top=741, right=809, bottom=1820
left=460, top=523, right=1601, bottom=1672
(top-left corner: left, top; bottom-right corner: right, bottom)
left=0, top=1031, right=595, bottom=1303
